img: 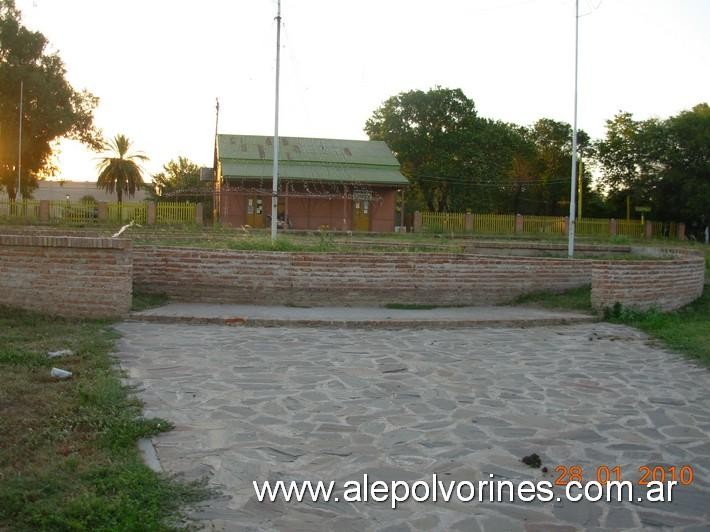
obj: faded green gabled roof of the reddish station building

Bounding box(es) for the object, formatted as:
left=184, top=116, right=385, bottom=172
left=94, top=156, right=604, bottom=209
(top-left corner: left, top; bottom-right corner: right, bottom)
left=217, top=135, right=408, bottom=185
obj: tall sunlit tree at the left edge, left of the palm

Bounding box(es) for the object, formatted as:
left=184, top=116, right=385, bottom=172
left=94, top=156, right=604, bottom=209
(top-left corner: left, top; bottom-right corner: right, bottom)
left=0, top=0, right=101, bottom=200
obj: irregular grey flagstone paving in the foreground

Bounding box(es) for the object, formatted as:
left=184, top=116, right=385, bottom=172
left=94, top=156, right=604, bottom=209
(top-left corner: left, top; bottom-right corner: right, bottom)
left=118, top=322, right=710, bottom=532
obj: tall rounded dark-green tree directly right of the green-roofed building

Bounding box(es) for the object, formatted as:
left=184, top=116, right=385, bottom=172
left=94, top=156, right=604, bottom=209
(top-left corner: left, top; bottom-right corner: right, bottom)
left=365, top=87, right=517, bottom=211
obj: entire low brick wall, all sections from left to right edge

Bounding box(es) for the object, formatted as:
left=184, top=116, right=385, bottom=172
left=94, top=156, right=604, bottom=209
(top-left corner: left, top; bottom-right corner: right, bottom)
left=0, top=235, right=705, bottom=317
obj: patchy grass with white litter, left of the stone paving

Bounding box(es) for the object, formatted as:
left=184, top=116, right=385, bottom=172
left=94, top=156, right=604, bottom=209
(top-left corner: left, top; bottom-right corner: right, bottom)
left=0, top=307, right=206, bottom=531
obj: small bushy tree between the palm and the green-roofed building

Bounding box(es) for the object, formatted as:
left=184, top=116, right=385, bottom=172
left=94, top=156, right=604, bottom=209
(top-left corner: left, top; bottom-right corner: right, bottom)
left=149, top=157, right=207, bottom=202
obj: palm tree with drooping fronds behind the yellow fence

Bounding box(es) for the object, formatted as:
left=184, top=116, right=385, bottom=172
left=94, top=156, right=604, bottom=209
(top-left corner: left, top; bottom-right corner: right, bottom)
left=96, top=135, right=148, bottom=203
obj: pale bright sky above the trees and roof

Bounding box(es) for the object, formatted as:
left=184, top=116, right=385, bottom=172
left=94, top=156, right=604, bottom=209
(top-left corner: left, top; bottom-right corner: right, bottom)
left=16, top=0, right=710, bottom=181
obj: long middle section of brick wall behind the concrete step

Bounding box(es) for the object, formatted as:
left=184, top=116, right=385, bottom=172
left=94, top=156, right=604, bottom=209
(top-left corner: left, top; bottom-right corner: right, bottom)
left=133, top=247, right=592, bottom=306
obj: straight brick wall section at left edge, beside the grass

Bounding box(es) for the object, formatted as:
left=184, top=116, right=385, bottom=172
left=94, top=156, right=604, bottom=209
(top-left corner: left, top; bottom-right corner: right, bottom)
left=0, top=235, right=133, bottom=318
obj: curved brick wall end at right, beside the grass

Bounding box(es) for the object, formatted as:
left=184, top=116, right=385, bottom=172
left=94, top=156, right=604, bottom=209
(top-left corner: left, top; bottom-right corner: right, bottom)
left=592, top=250, right=705, bottom=310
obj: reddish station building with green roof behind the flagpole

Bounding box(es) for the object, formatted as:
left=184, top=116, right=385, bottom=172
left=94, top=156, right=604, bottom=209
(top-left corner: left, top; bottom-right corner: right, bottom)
left=214, top=135, right=408, bottom=232
